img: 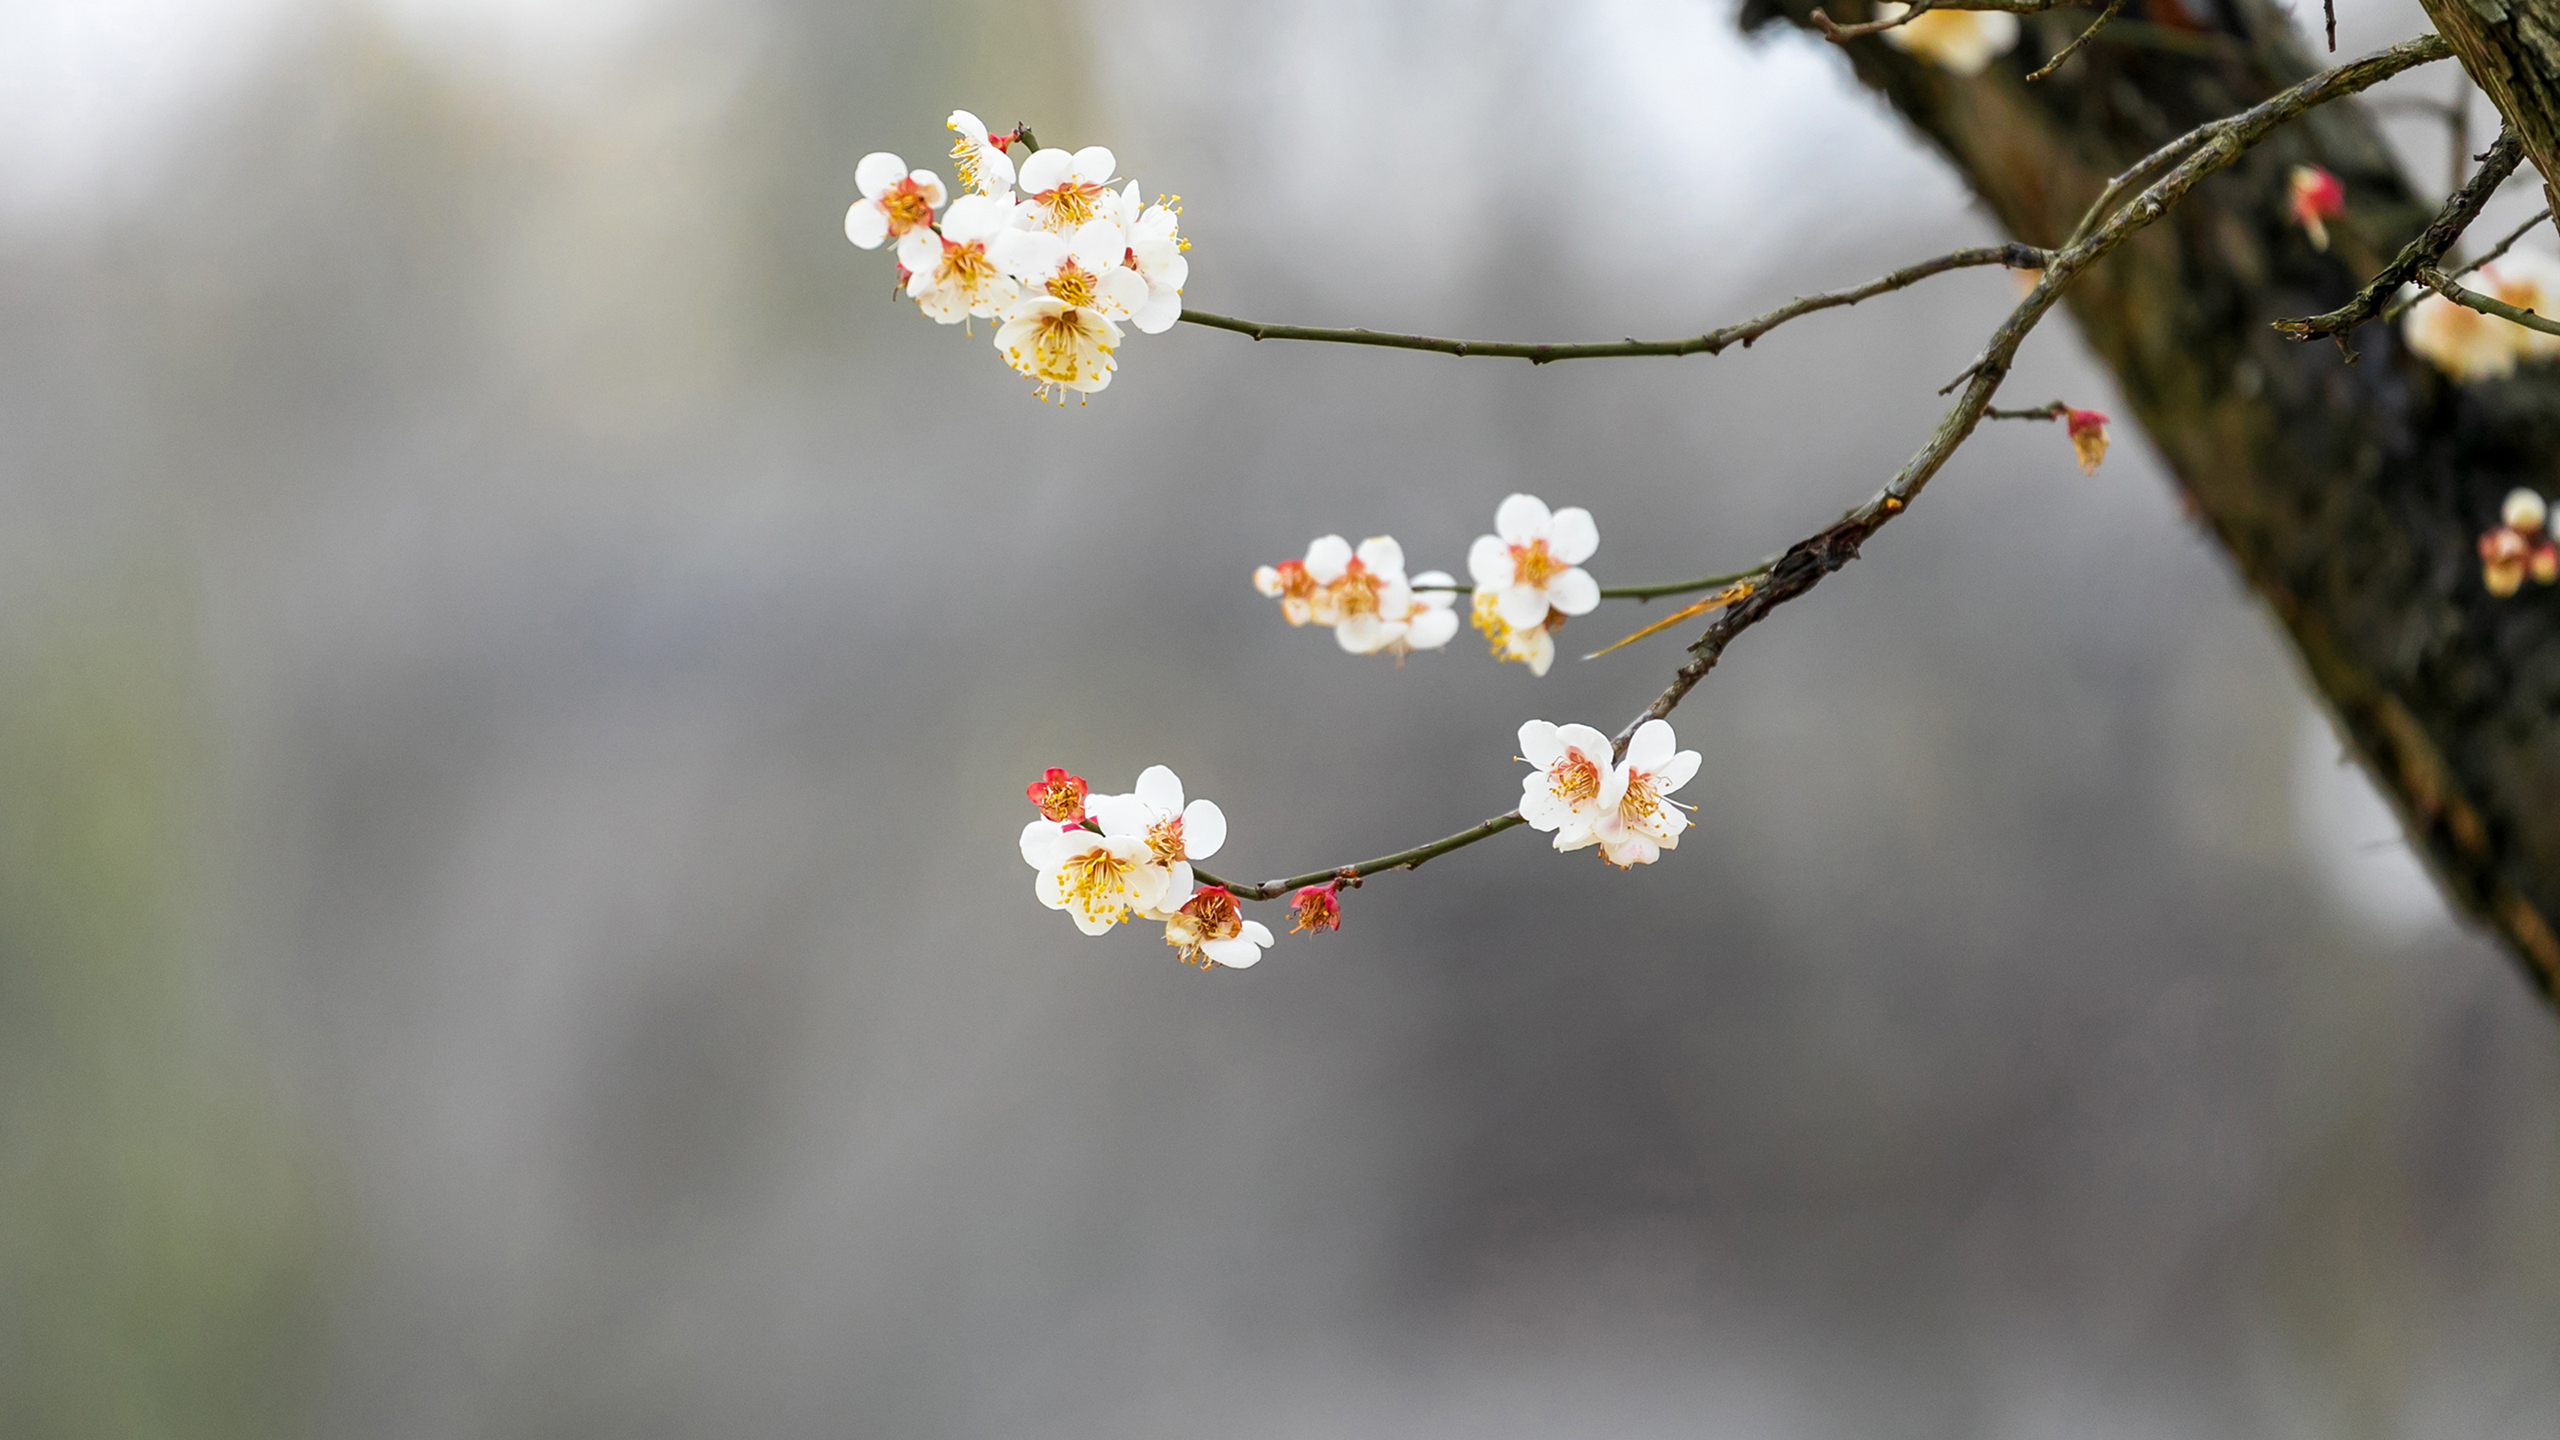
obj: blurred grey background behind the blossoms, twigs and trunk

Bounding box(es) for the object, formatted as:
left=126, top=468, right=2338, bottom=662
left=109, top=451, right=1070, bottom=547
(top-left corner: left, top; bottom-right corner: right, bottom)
left=0, top=0, right=2560, bottom=1437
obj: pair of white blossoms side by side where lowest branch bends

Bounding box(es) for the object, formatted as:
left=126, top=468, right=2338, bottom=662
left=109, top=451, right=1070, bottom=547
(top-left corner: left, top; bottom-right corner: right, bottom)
left=1521, top=720, right=1697, bottom=869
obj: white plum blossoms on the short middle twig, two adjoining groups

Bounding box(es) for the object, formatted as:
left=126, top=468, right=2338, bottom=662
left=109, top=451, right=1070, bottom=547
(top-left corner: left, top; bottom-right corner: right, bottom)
left=1254, top=495, right=1600, bottom=674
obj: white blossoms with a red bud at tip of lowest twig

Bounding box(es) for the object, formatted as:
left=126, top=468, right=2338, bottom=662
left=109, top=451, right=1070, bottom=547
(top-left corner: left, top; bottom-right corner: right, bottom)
left=1021, top=766, right=1272, bottom=969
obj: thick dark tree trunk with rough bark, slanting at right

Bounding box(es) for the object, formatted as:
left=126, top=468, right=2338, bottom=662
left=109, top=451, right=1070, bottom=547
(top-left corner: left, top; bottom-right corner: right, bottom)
left=1743, top=0, right=2560, bottom=997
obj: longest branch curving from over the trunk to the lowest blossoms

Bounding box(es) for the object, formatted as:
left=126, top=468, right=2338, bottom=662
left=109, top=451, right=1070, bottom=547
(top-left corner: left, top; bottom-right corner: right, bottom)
left=1193, top=33, right=2447, bottom=899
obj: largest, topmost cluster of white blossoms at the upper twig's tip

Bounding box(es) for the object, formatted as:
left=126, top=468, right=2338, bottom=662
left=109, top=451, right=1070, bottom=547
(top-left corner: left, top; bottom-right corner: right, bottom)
left=845, top=110, right=1190, bottom=400
